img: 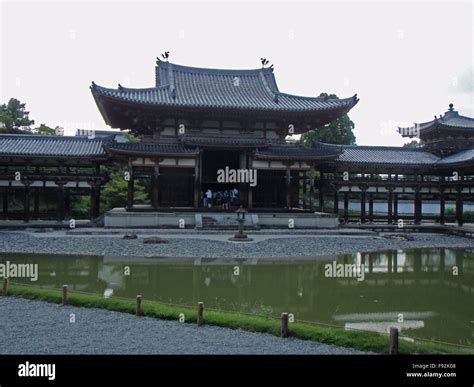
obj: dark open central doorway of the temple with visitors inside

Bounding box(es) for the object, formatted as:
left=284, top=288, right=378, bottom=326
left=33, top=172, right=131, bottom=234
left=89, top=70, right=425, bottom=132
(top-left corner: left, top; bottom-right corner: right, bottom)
left=200, top=149, right=246, bottom=210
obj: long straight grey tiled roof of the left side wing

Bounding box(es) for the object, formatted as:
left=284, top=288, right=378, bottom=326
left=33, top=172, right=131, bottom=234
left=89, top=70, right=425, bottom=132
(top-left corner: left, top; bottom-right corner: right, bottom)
left=0, top=134, right=105, bottom=157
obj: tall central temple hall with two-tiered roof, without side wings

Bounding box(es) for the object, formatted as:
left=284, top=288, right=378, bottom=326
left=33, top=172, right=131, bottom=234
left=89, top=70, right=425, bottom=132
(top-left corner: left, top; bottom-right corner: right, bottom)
left=91, top=61, right=358, bottom=209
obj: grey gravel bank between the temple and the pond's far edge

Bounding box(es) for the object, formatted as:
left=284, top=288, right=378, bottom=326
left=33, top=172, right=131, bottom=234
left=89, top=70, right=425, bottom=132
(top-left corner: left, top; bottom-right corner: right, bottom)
left=0, top=232, right=474, bottom=258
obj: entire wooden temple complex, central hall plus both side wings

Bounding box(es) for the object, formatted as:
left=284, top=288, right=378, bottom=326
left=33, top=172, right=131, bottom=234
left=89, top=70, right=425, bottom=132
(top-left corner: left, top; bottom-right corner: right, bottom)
left=0, top=61, right=474, bottom=229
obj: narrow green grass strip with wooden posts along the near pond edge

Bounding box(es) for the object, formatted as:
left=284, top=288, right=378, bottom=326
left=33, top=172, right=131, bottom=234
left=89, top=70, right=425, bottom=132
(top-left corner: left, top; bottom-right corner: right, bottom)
left=3, top=284, right=474, bottom=354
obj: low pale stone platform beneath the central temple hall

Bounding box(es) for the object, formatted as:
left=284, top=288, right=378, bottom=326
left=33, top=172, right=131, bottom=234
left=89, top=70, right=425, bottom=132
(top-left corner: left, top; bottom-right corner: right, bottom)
left=104, top=208, right=338, bottom=230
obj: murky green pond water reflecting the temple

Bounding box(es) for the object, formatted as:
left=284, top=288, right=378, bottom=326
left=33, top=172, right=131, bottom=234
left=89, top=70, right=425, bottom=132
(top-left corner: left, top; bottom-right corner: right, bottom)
left=0, top=248, right=474, bottom=346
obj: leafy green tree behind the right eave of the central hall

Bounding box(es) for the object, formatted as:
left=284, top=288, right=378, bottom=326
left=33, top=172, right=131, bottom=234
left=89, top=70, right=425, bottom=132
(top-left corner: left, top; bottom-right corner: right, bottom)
left=301, top=93, right=356, bottom=146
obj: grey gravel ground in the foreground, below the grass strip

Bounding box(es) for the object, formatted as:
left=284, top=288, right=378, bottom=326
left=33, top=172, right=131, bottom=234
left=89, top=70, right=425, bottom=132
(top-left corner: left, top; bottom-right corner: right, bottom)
left=0, top=297, right=364, bottom=354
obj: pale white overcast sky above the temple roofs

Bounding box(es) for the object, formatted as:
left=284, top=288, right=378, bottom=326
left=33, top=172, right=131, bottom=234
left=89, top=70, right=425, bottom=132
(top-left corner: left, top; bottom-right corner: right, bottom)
left=0, top=0, right=474, bottom=145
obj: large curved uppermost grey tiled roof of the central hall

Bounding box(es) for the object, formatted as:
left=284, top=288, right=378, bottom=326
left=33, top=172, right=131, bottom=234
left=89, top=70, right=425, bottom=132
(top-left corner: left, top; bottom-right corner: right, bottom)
left=91, top=62, right=358, bottom=112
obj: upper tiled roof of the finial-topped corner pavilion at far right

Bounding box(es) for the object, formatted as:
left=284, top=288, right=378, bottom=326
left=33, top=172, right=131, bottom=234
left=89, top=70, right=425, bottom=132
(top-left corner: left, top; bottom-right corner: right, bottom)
left=398, top=104, right=474, bottom=137
